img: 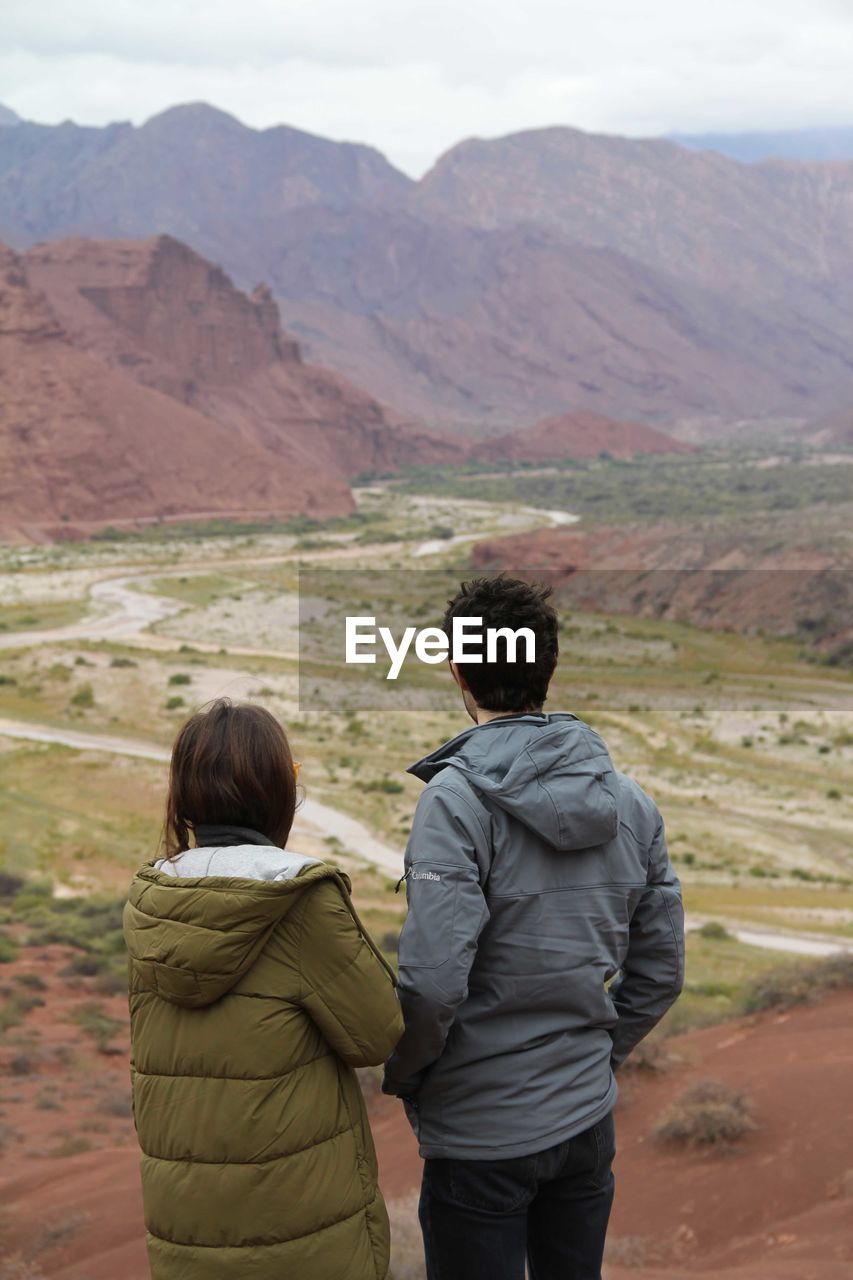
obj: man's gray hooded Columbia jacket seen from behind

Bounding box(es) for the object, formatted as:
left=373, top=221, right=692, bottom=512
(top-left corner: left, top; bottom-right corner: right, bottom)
left=383, top=714, right=684, bottom=1160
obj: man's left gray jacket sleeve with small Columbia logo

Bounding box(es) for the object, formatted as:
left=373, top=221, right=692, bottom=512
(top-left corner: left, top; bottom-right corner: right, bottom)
left=382, top=787, right=489, bottom=1098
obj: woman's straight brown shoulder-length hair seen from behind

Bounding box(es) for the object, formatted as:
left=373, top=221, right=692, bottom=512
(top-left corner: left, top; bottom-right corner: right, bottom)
left=164, top=698, right=296, bottom=858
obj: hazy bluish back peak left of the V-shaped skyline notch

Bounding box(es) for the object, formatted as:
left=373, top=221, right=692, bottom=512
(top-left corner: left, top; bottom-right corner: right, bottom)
left=0, top=102, right=410, bottom=249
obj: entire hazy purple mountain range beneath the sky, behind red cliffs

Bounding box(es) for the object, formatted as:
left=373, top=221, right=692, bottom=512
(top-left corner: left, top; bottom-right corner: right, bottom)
left=0, top=105, right=853, bottom=435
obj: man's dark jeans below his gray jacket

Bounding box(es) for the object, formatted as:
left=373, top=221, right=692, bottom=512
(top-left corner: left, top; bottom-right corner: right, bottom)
left=420, top=1114, right=616, bottom=1280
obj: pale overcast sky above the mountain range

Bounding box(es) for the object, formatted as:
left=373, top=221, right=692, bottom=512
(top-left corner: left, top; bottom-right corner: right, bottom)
left=0, top=0, right=853, bottom=175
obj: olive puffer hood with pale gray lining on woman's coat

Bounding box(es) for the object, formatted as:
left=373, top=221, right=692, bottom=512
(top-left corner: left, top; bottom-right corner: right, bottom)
left=123, top=845, right=350, bottom=1009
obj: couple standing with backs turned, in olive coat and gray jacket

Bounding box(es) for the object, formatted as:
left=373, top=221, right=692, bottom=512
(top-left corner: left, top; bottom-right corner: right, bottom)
left=126, top=577, right=684, bottom=1280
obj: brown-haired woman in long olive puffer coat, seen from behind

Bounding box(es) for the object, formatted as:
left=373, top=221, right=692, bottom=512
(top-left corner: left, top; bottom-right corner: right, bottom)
left=124, top=700, right=402, bottom=1280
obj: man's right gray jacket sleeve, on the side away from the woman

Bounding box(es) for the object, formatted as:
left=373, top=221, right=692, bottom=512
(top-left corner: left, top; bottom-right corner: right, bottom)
left=610, top=814, right=684, bottom=1068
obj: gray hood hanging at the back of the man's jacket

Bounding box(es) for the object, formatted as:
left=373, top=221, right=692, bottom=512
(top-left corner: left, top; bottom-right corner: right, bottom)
left=409, top=713, right=619, bottom=852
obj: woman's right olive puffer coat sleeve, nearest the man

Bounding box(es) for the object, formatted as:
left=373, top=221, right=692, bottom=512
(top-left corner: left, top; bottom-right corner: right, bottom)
left=300, top=881, right=403, bottom=1066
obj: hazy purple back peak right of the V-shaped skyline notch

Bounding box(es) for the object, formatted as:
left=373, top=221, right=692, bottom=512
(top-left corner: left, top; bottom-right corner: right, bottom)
left=414, top=128, right=853, bottom=307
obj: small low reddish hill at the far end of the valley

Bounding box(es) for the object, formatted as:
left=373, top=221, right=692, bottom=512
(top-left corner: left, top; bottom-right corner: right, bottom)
left=471, top=411, right=692, bottom=462
